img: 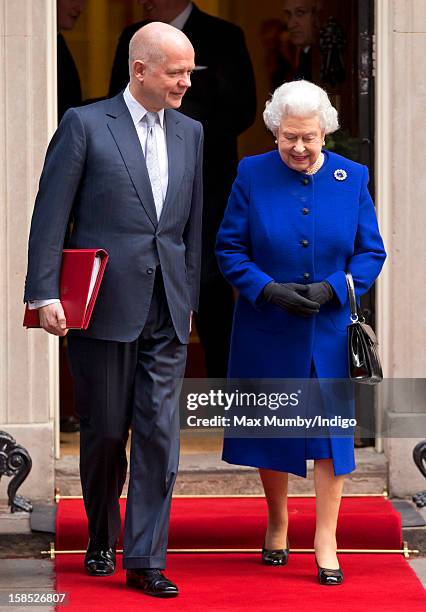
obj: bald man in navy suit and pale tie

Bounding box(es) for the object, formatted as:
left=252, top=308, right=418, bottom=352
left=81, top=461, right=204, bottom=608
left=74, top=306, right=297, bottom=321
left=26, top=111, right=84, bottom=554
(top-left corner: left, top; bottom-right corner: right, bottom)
left=24, top=23, right=203, bottom=597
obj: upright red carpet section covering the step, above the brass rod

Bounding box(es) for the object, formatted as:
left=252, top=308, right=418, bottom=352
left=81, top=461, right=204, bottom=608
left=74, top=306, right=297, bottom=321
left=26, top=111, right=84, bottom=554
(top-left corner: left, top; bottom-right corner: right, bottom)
left=56, top=497, right=401, bottom=550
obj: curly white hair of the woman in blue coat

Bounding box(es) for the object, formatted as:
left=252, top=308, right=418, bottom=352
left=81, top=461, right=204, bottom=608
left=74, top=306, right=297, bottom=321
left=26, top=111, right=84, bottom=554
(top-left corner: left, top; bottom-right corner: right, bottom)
left=263, top=80, right=339, bottom=136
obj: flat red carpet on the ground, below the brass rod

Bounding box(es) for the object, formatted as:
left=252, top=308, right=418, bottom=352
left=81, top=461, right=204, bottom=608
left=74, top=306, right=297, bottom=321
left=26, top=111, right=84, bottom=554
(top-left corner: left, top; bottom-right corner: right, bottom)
left=56, top=553, right=426, bottom=612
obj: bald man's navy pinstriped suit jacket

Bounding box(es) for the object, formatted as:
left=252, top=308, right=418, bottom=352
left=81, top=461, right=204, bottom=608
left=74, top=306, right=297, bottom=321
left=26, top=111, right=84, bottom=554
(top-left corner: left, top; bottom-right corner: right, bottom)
left=24, top=93, right=203, bottom=343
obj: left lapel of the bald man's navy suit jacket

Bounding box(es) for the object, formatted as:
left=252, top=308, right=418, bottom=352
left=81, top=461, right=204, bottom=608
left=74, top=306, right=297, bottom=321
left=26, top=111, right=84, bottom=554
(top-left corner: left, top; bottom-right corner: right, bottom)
left=107, top=93, right=158, bottom=227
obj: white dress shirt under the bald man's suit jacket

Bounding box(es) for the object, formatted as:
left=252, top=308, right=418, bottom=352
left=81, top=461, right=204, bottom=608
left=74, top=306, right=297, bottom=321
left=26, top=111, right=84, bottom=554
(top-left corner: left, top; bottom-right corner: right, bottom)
left=28, top=83, right=170, bottom=310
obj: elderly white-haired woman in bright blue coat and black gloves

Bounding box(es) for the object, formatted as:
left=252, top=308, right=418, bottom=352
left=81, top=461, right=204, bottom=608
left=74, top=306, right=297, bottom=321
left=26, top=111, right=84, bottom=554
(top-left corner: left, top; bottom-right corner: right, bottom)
left=216, top=81, right=386, bottom=585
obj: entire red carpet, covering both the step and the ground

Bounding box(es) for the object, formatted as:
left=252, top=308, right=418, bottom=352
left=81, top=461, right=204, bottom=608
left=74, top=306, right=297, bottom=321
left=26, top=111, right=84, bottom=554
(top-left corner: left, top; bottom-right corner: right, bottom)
left=55, top=498, right=426, bottom=612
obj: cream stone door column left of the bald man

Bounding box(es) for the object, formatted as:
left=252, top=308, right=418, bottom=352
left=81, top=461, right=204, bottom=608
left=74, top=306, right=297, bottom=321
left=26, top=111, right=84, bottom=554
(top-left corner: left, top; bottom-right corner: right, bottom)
left=0, top=0, right=58, bottom=499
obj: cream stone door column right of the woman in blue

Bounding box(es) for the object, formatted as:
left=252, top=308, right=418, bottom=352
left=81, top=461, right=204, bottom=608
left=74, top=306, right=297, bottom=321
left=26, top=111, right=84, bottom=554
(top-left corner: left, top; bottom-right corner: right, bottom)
left=376, top=0, right=426, bottom=496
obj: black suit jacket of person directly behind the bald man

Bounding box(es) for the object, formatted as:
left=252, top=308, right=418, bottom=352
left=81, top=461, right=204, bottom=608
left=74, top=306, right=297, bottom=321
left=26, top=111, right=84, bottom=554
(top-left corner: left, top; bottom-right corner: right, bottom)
left=109, top=6, right=256, bottom=280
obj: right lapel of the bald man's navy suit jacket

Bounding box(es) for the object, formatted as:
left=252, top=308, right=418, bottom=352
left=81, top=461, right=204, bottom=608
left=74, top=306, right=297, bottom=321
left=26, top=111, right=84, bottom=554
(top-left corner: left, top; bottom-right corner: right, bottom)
left=160, top=110, right=185, bottom=224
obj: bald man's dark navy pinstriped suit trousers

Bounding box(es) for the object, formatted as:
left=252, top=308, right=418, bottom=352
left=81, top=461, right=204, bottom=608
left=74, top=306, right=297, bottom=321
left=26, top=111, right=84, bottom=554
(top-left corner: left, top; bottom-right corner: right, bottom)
left=68, top=267, right=189, bottom=569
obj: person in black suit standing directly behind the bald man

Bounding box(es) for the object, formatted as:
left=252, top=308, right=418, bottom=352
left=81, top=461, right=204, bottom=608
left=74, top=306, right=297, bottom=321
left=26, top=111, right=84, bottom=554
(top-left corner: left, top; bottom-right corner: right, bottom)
left=109, top=0, right=256, bottom=378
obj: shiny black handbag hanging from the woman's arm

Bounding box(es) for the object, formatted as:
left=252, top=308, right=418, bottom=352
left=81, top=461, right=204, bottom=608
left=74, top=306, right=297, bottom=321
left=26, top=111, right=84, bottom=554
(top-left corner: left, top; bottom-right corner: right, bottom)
left=346, top=272, right=383, bottom=385
